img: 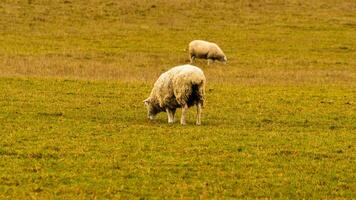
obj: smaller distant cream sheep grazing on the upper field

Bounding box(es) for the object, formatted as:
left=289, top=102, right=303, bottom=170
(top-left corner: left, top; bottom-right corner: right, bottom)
left=189, top=40, right=227, bottom=65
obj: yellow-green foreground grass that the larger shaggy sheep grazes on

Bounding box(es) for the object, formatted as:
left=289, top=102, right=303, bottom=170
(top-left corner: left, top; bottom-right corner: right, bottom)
left=0, top=78, right=356, bottom=199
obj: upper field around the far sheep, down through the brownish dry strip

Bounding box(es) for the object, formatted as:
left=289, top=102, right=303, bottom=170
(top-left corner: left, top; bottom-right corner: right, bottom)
left=0, top=0, right=356, bottom=85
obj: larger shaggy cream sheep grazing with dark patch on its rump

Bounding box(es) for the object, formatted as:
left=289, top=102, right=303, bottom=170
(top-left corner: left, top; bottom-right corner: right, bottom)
left=143, top=65, right=206, bottom=125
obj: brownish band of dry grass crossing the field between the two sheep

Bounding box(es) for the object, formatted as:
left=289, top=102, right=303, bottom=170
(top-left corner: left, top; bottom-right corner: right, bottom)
left=0, top=55, right=356, bottom=85
